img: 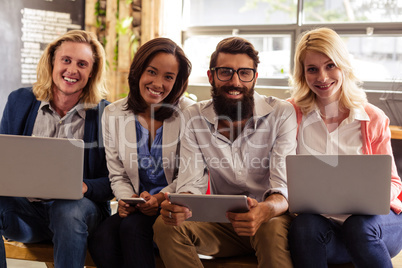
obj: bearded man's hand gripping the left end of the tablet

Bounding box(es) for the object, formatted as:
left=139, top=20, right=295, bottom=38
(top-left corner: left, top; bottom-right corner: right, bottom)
left=161, top=193, right=192, bottom=226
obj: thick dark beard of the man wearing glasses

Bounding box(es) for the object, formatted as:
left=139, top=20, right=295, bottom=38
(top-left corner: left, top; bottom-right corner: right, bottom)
left=212, top=83, right=254, bottom=122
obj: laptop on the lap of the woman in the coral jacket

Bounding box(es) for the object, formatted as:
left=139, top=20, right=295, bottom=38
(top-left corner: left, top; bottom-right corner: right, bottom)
left=286, top=155, right=392, bottom=215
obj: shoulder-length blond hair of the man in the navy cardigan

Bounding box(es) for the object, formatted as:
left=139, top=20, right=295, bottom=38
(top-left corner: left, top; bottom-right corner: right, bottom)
left=33, top=30, right=108, bottom=108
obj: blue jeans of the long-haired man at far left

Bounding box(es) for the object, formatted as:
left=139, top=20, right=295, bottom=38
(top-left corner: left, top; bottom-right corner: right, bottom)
left=0, top=197, right=103, bottom=268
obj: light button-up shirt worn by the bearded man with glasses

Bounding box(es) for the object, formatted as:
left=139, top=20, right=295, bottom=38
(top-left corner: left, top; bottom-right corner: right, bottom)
left=177, top=93, right=297, bottom=202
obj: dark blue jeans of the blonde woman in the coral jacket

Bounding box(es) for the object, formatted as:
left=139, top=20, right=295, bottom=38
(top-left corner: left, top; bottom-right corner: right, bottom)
left=289, top=211, right=402, bottom=268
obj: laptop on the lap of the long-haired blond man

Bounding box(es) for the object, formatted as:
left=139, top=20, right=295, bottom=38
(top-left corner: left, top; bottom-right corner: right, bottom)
left=0, top=135, right=84, bottom=199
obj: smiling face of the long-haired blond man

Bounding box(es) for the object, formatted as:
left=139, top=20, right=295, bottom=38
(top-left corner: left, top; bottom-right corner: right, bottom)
left=52, top=42, right=94, bottom=98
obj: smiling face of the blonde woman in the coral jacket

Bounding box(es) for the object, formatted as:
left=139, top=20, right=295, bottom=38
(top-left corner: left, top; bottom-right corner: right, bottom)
left=304, top=51, right=343, bottom=104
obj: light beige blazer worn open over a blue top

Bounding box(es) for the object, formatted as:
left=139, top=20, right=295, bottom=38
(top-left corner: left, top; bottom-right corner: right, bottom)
left=102, top=97, right=194, bottom=200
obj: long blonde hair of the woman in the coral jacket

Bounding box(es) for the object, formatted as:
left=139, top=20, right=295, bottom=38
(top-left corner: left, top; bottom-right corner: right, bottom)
left=289, top=28, right=367, bottom=114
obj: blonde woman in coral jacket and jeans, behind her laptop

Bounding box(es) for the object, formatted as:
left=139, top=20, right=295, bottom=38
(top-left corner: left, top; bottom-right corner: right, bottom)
left=289, top=28, right=402, bottom=267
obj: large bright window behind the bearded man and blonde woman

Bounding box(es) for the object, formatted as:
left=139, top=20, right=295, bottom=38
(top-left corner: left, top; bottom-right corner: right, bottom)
left=177, top=0, right=402, bottom=90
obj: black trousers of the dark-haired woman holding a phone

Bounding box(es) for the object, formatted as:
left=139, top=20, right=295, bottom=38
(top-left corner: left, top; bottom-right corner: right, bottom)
left=89, top=212, right=158, bottom=268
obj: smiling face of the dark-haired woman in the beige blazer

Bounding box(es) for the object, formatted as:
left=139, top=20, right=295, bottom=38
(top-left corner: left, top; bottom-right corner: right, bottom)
left=139, top=53, right=179, bottom=106
